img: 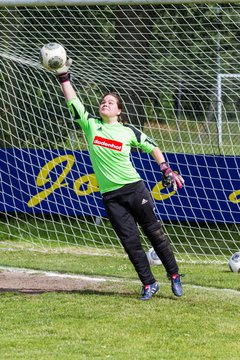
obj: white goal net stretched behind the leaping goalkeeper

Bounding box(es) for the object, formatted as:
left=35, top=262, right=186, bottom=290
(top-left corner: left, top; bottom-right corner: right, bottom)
left=0, top=0, right=240, bottom=262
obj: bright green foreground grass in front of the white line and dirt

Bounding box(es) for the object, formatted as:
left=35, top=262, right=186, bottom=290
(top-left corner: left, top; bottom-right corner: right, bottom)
left=0, top=287, right=240, bottom=360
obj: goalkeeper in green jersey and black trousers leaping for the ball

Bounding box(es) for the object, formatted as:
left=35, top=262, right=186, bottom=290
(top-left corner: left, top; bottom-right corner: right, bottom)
left=49, top=59, right=184, bottom=300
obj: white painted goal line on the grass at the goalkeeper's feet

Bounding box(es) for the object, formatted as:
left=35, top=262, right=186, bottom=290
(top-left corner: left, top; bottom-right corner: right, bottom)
left=0, top=266, right=240, bottom=296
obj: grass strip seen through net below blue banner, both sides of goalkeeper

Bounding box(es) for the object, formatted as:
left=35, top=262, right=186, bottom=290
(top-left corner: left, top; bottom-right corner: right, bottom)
left=0, top=214, right=240, bottom=261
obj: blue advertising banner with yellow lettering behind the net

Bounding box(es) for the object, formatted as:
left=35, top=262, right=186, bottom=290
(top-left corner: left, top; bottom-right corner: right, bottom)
left=0, top=148, right=240, bottom=223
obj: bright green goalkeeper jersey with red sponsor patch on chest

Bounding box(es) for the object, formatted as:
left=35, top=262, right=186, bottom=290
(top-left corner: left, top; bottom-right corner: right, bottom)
left=67, top=97, right=157, bottom=194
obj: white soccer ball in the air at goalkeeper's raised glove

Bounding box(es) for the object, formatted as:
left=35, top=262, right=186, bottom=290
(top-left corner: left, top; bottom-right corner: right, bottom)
left=40, top=42, right=67, bottom=70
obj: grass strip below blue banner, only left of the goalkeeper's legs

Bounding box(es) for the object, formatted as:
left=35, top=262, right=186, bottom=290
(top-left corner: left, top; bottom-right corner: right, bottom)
left=0, top=213, right=119, bottom=247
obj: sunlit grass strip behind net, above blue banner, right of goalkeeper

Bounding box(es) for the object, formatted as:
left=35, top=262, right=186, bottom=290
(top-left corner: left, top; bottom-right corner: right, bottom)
left=143, top=120, right=240, bottom=156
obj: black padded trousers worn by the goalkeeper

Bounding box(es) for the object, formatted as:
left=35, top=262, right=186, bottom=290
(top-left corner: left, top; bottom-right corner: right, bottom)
left=103, top=181, right=178, bottom=285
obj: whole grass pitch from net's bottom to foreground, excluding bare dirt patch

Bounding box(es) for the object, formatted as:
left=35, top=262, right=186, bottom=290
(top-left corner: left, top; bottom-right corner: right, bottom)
left=0, top=248, right=240, bottom=360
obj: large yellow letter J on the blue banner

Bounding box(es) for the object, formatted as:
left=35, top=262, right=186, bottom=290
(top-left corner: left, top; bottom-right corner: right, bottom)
left=28, top=155, right=75, bottom=207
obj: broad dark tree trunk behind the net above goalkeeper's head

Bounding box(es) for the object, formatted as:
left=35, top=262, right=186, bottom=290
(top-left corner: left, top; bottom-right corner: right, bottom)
left=112, top=5, right=154, bottom=127
